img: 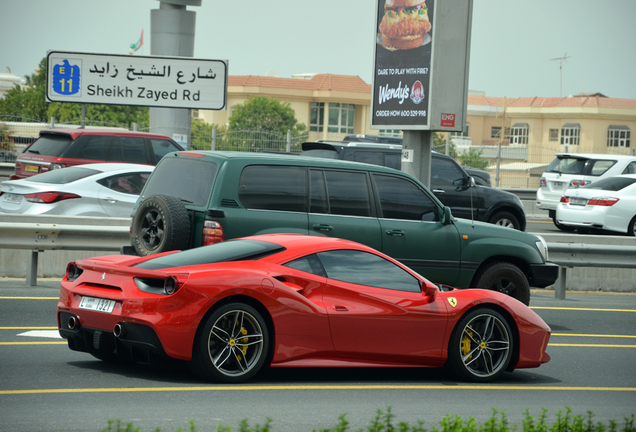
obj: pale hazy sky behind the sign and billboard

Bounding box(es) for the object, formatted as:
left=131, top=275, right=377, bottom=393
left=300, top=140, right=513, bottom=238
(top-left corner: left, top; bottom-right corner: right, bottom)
left=0, top=0, right=636, bottom=99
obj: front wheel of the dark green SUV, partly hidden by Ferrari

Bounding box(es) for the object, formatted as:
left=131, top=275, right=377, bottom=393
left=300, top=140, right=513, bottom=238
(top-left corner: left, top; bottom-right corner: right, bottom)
left=476, top=262, right=530, bottom=306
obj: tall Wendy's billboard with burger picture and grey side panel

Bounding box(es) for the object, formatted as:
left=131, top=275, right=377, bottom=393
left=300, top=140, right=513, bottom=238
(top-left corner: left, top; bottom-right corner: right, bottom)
left=371, top=0, right=472, bottom=131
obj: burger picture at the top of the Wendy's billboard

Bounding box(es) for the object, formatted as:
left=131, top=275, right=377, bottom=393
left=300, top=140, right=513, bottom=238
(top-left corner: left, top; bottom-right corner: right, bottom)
left=380, top=0, right=431, bottom=49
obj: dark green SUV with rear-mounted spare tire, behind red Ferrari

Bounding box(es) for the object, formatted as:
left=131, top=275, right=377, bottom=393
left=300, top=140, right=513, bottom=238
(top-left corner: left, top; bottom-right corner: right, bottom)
left=131, top=151, right=558, bottom=304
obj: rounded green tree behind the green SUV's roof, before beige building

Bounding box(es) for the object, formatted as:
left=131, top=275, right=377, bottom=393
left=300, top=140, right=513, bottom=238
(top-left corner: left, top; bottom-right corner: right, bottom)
left=228, top=96, right=307, bottom=135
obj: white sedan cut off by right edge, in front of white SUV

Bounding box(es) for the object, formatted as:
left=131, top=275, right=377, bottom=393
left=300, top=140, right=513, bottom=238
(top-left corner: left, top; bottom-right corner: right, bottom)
left=556, top=174, right=636, bottom=236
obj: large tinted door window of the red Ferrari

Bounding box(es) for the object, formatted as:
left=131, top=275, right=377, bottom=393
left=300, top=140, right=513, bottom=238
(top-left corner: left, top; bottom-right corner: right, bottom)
left=317, top=250, right=421, bottom=292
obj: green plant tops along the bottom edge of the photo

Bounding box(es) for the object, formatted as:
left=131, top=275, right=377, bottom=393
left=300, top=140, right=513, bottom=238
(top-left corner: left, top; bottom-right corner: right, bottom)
left=76, top=407, right=636, bottom=432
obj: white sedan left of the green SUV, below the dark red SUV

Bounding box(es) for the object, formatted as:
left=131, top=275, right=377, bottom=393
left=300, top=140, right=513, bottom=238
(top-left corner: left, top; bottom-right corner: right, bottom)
left=0, top=163, right=155, bottom=217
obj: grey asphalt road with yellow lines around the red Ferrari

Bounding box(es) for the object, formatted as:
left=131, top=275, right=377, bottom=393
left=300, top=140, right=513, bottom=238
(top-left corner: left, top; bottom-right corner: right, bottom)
left=0, top=279, right=636, bottom=432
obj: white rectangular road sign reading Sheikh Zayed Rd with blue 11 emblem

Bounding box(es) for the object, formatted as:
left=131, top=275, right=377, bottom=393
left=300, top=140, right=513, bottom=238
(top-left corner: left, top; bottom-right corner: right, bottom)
left=46, top=51, right=228, bottom=110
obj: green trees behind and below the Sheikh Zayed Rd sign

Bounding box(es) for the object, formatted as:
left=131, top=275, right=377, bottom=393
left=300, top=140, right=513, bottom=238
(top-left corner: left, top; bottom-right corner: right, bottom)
left=0, top=57, right=149, bottom=127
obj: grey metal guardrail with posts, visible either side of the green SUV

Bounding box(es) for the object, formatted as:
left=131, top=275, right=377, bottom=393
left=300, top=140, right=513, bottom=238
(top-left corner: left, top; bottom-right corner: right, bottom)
left=0, top=214, right=636, bottom=300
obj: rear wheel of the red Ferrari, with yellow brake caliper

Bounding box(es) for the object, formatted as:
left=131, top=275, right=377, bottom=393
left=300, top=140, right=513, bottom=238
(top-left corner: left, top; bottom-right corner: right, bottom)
left=191, top=303, right=269, bottom=383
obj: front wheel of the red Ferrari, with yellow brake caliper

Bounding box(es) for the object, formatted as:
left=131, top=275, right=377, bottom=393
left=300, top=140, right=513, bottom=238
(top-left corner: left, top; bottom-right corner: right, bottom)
left=448, top=308, right=515, bottom=382
